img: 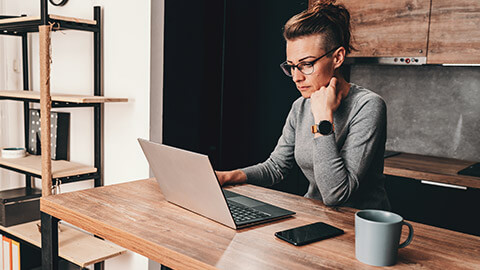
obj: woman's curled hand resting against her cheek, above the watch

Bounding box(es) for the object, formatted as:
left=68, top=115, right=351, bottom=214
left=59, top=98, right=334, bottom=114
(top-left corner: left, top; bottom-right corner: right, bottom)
left=310, top=77, right=342, bottom=123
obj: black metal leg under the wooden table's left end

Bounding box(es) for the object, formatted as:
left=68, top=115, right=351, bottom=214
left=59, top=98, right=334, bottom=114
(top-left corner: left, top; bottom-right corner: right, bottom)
left=41, top=212, right=58, bottom=270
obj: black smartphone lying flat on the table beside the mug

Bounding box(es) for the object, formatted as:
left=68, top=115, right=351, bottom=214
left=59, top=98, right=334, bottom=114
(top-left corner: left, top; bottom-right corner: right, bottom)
left=275, top=222, right=344, bottom=246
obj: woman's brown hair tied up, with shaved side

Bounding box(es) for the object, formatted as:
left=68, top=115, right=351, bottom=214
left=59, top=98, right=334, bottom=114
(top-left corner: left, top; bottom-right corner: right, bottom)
left=283, top=0, right=355, bottom=54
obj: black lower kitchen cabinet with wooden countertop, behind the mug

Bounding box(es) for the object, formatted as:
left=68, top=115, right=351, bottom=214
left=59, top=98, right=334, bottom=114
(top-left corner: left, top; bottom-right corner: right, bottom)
left=384, top=153, right=480, bottom=235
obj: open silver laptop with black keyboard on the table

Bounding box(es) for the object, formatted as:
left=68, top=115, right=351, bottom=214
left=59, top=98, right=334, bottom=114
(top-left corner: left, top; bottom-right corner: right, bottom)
left=138, top=138, right=295, bottom=229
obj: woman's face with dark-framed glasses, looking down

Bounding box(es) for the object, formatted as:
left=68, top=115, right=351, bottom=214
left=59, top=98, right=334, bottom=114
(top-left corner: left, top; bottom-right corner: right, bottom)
left=287, top=35, right=335, bottom=98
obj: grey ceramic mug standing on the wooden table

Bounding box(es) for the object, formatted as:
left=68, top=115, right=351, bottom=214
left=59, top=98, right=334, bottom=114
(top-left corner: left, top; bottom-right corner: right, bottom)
left=355, top=210, right=413, bottom=266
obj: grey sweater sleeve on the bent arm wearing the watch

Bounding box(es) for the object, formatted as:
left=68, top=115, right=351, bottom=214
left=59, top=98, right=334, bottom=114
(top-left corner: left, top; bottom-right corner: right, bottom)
left=313, top=96, right=386, bottom=205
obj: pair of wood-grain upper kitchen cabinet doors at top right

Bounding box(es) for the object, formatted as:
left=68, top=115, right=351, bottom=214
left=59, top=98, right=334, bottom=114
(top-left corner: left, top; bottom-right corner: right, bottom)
left=310, top=0, right=480, bottom=64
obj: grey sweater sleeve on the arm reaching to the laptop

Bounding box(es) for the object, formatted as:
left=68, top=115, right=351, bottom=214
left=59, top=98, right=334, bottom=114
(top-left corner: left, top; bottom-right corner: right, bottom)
left=241, top=103, right=296, bottom=186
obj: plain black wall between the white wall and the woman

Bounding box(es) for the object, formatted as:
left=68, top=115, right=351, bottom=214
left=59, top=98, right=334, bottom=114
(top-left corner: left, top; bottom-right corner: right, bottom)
left=163, top=0, right=307, bottom=195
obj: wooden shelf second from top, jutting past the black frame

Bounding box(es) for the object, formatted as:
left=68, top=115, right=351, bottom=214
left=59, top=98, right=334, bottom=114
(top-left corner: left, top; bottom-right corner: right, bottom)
left=0, top=90, right=128, bottom=104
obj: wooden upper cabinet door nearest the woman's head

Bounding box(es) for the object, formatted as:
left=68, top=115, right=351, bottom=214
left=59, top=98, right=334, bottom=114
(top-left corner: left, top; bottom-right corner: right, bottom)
left=310, top=0, right=430, bottom=57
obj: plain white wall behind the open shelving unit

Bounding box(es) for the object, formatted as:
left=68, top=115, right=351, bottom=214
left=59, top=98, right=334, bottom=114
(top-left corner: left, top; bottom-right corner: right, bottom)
left=0, top=0, right=151, bottom=270
